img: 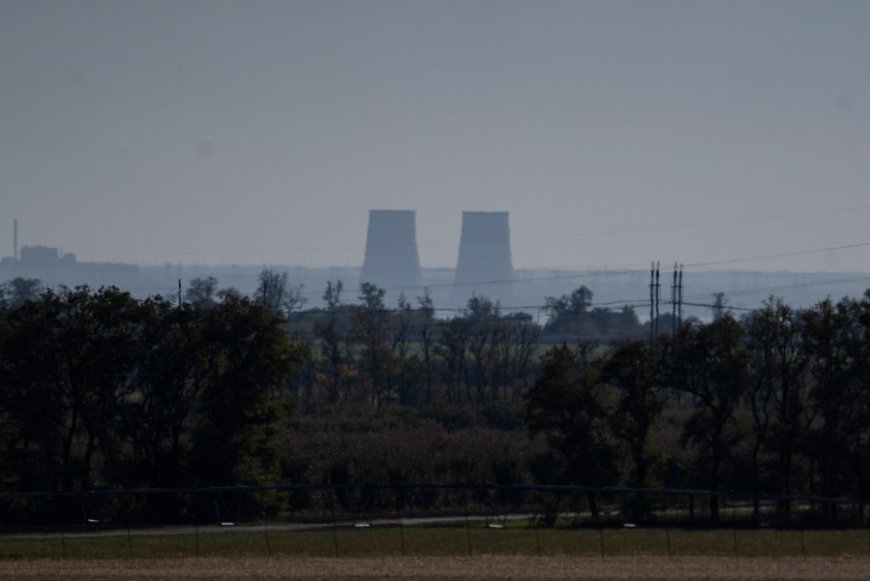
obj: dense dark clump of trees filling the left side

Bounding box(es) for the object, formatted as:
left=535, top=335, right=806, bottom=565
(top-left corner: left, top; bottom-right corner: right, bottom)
left=0, top=287, right=307, bottom=491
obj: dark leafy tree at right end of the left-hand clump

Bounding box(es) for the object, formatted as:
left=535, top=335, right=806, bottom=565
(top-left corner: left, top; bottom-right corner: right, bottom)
left=193, top=299, right=306, bottom=486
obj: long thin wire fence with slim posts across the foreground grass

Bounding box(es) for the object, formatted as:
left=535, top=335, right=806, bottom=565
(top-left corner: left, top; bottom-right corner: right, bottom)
left=0, top=483, right=870, bottom=559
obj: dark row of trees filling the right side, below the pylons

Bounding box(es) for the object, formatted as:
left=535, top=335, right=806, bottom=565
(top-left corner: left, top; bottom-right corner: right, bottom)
left=527, top=291, right=870, bottom=518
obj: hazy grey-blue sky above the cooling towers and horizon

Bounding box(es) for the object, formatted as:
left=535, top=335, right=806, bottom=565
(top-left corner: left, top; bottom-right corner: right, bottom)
left=0, top=0, right=870, bottom=271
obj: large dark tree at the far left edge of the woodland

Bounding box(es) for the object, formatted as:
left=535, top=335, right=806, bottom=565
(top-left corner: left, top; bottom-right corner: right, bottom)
left=2, top=287, right=140, bottom=491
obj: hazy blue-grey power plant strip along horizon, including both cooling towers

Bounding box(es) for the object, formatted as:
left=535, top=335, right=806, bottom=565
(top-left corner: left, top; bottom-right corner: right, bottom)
left=0, top=216, right=866, bottom=318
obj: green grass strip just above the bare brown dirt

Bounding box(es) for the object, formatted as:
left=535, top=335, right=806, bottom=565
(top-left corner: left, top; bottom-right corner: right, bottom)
left=0, top=523, right=870, bottom=560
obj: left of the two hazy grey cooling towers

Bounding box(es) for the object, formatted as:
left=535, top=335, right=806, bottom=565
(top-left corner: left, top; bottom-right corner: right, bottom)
left=360, top=210, right=420, bottom=289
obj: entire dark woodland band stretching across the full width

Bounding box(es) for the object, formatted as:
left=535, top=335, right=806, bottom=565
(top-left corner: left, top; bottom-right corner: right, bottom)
left=0, top=270, right=870, bottom=510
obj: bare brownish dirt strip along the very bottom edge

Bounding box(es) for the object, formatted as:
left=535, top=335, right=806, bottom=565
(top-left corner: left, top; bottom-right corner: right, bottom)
left=0, top=557, right=870, bottom=581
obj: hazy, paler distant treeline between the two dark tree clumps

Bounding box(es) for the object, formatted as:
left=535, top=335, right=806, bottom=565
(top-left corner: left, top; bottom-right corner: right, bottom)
left=287, top=281, right=645, bottom=412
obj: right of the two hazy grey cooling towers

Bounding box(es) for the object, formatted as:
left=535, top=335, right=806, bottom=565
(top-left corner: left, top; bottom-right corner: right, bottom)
left=456, top=212, right=514, bottom=293
